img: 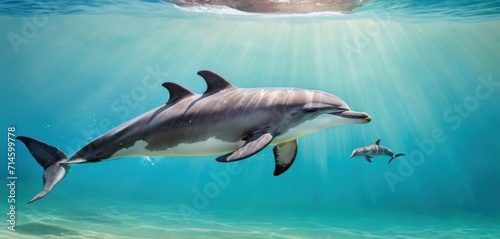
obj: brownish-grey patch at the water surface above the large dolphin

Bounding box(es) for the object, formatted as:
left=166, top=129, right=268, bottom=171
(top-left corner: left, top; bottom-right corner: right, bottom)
left=167, top=0, right=369, bottom=14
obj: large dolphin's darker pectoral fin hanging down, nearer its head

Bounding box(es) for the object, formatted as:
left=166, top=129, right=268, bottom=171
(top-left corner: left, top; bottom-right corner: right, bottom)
left=273, top=139, right=298, bottom=176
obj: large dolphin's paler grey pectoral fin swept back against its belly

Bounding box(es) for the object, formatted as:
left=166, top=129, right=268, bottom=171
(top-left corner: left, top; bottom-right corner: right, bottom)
left=216, top=132, right=274, bottom=162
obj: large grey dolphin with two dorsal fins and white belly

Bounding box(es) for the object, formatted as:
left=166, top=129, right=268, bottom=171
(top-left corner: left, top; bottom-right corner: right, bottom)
left=18, top=71, right=371, bottom=203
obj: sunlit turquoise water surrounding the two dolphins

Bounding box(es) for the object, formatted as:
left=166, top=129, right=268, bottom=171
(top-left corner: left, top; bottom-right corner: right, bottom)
left=0, top=1, right=500, bottom=238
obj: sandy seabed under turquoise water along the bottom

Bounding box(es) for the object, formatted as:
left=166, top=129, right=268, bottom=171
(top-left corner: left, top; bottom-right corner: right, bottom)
left=4, top=202, right=500, bottom=238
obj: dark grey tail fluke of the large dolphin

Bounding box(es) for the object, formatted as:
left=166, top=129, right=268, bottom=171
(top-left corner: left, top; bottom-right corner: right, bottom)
left=17, top=136, right=69, bottom=203
